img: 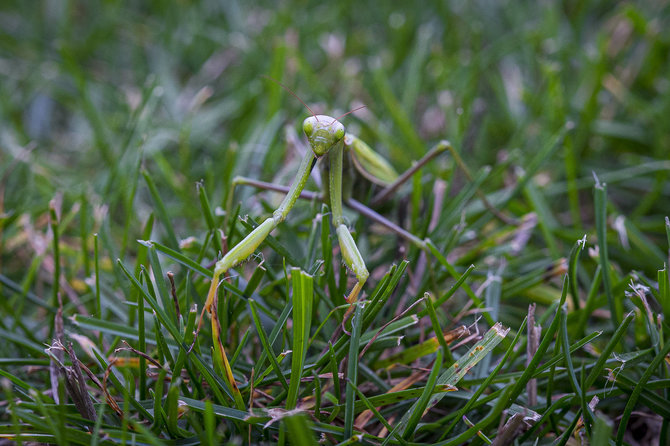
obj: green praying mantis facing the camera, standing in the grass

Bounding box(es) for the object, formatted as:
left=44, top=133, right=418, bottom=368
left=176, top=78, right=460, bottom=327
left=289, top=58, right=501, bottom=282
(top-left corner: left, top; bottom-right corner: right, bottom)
left=198, top=79, right=451, bottom=342
